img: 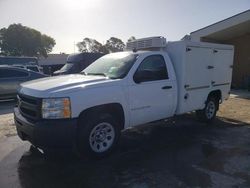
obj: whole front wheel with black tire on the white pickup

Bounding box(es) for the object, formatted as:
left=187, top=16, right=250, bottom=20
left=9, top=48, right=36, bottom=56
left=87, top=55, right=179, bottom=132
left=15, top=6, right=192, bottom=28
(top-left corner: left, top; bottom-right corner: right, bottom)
left=77, top=113, right=121, bottom=159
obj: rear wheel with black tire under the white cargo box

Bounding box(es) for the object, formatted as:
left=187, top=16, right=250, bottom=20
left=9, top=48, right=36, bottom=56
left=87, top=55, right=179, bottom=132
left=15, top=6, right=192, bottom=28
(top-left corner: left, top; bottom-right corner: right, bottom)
left=196, top=97, right=219, bottom=123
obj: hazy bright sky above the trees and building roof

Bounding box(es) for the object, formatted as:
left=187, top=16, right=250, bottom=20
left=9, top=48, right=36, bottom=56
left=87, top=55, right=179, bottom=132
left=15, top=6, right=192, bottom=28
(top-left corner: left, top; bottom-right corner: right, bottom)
left=0, top=0, right=250, bottom=53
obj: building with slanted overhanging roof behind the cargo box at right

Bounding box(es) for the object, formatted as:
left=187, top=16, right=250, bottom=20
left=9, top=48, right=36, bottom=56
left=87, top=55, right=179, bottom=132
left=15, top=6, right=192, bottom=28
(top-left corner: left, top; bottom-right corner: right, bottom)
left=190, top=10, right=250, bottom=89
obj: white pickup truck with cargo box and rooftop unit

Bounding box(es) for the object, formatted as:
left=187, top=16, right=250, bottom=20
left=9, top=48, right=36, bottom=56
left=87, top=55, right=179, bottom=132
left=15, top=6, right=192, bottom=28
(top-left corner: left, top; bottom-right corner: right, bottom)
left=14, top=37, right=234, bottom=157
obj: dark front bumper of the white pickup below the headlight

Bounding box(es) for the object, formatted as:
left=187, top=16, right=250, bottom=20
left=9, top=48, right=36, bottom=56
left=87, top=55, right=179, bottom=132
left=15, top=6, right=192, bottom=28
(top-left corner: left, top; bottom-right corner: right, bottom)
left=14, top=108, right=77, bottom=149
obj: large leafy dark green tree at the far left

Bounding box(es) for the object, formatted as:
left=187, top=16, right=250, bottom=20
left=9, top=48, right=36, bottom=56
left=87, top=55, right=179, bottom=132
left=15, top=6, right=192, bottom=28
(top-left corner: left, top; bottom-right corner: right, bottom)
left=0, top=24, right=56, bottom=57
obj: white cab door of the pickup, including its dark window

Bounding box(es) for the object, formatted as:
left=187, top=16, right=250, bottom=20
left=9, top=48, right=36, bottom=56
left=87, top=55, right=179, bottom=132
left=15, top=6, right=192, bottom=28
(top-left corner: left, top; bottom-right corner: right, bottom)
left=129, top=54, right=176, bottom=126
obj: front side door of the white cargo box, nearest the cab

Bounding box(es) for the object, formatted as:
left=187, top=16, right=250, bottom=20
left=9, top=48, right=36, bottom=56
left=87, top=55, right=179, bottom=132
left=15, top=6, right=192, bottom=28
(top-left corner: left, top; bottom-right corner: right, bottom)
left=182, top=46, right=213, bottom=112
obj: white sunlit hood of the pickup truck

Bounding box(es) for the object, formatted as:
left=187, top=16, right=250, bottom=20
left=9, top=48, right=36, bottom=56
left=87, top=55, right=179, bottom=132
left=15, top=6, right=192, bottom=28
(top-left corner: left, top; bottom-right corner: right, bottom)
left=18, top=74, right=113, bottom=98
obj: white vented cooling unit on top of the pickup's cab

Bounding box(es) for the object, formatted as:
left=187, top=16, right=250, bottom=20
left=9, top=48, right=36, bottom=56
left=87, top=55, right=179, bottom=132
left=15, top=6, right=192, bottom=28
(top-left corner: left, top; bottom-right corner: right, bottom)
left=126, top=37, right=167, bottom=50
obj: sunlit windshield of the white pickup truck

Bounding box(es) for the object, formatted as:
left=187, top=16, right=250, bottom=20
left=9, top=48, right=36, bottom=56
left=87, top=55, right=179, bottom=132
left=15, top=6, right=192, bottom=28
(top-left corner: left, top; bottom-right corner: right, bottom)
left=82, top=52, right=138, bottom=79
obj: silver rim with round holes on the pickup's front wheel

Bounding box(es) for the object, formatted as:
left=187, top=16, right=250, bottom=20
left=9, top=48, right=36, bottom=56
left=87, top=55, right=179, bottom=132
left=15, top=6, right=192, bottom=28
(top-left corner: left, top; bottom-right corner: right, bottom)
left=89, top=122, right=115, bottom=153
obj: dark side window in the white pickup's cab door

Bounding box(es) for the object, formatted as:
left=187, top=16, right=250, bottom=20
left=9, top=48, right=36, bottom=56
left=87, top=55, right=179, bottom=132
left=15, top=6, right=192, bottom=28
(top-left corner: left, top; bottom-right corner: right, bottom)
left=134, top=55, right=168, bottom=83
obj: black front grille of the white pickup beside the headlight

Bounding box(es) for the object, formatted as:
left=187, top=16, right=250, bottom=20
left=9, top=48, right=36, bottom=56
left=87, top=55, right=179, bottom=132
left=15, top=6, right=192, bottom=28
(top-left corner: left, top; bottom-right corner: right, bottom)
left=17, top=94, right=41, bottom=121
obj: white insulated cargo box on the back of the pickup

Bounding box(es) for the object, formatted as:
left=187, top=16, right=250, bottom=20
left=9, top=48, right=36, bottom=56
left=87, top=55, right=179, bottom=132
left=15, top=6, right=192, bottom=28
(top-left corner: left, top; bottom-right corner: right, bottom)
left=166, top=41, right=234, bottom=114
